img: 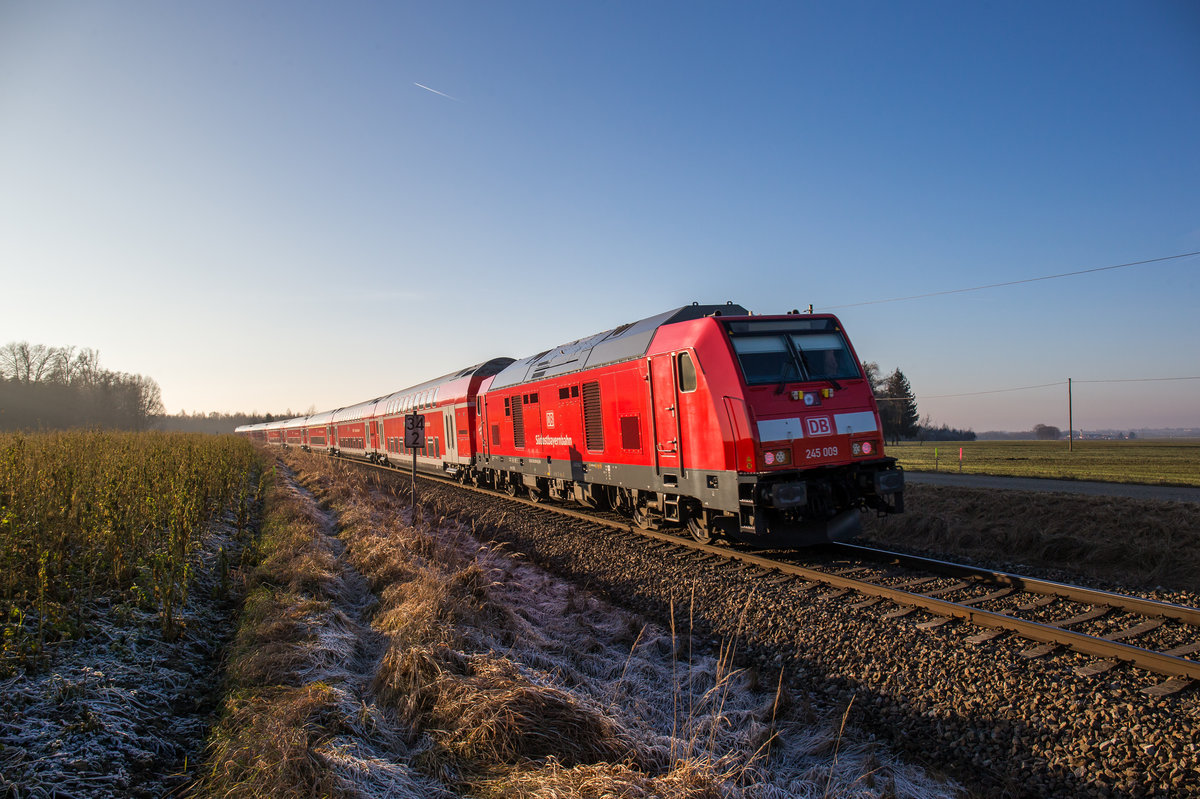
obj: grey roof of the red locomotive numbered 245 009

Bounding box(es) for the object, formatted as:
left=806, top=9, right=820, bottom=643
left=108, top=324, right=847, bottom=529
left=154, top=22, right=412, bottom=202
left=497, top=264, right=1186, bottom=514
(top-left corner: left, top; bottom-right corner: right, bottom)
left=492, top=302, right=750, bottom=389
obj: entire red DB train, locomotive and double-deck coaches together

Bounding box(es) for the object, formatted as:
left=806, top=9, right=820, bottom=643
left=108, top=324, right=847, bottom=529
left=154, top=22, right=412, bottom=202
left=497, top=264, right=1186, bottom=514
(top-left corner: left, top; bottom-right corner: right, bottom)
left=238, top=304, right=904, bottom=545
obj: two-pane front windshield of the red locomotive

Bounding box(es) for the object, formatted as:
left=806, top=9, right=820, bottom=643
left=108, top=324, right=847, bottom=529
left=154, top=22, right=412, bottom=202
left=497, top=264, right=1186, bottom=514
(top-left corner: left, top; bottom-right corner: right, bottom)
left=726, top=319, right=862, bottom=385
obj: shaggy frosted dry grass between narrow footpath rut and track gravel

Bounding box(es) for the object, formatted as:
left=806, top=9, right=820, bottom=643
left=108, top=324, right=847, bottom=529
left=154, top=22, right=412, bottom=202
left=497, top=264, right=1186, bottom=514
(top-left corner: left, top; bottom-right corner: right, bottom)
left=288, top=458, right=948, bottom=799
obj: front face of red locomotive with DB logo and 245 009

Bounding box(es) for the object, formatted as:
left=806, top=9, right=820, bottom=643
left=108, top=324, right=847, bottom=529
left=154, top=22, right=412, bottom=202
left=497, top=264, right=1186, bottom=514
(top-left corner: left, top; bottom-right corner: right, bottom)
left=722, top=314, right=904, bottom=543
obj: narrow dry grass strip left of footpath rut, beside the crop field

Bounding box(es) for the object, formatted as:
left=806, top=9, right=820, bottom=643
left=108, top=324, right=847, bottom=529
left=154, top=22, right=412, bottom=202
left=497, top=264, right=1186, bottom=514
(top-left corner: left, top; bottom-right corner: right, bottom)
left=197, top=470, right=374, bottom=799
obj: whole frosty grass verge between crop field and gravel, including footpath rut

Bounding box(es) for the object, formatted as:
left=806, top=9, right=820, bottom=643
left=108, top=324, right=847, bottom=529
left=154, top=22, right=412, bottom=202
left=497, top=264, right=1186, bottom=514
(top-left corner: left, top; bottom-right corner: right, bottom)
left=202, top=456, right=954, bottom=799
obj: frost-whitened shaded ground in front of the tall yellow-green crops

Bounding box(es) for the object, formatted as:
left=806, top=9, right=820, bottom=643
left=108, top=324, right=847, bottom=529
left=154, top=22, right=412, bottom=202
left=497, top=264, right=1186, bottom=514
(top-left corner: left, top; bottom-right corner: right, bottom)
left=0, top=517, right=255, bottom=799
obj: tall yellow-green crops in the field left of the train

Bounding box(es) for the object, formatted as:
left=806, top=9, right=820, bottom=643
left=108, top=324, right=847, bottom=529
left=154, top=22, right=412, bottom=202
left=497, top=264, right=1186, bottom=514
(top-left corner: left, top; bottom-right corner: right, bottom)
left=0, top=432, right=263, bottom=673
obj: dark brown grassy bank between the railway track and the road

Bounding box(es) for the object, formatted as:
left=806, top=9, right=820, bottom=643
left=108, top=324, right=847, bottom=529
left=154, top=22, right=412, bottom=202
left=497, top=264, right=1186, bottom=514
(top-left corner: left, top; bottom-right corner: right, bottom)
left=864, top=483, right=1200, bottom=601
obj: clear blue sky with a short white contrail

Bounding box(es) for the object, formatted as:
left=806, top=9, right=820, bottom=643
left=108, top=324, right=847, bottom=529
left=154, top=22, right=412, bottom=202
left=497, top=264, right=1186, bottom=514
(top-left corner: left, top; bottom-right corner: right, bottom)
left=0, top=0, right=1200, bottom=432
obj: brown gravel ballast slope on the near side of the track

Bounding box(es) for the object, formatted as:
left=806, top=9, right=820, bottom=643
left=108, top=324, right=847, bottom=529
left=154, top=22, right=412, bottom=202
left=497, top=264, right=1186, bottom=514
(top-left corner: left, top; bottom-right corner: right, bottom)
left=403, top=472, right=1200, bottom=797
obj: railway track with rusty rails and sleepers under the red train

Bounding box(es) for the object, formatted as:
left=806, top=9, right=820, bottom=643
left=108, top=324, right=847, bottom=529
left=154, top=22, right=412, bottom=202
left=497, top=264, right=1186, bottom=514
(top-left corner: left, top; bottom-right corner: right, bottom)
left=338, top=451, right=1200, bottom=696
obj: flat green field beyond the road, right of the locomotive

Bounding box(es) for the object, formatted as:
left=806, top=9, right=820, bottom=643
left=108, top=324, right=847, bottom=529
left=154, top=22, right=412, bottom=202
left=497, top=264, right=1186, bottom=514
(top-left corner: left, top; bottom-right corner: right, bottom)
left=887, top=439, right=1200, bottom=486
